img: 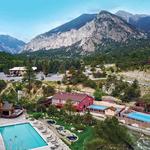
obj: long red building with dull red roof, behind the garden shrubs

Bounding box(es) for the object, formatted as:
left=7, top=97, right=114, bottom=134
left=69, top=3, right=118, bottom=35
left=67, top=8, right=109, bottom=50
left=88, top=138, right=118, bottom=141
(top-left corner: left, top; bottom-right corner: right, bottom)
left=51, top=92, right=94, bottom=111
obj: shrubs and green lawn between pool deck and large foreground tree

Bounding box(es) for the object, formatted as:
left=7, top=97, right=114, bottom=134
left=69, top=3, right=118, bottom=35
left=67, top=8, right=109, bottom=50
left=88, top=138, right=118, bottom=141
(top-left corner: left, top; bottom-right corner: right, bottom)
left=28, top=103, right=96, bottom=150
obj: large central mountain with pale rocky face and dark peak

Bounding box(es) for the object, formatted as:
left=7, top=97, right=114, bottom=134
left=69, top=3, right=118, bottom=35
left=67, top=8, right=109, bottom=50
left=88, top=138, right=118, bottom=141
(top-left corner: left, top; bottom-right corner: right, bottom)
left=24, top=11, right=145, bottom=52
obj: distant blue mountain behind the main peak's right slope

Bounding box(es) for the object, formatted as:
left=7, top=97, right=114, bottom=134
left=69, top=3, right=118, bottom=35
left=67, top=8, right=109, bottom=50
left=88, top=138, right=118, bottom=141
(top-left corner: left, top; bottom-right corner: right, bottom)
left=116, top=10, right=150, bottom=33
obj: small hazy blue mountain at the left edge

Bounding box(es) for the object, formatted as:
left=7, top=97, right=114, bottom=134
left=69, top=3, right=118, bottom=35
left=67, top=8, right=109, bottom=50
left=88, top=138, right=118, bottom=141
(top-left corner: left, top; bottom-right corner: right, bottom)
left=0, top=35, right=25, bottom=54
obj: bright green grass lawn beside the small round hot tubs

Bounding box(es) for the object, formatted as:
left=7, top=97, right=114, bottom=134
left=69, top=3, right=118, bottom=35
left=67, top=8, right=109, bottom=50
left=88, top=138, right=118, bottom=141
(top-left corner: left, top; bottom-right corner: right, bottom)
left=51, top=119, right=93, bottom=150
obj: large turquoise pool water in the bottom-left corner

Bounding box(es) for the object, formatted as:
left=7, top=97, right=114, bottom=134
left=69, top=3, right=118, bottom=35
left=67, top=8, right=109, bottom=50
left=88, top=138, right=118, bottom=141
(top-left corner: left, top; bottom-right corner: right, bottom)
left=0, top=123, right=47, bottom=150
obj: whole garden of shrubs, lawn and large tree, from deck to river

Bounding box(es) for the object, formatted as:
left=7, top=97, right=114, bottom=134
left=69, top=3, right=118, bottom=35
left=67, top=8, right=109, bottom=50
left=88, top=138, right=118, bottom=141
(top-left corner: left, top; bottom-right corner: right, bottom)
left=27, top=101, right=135, bottom=150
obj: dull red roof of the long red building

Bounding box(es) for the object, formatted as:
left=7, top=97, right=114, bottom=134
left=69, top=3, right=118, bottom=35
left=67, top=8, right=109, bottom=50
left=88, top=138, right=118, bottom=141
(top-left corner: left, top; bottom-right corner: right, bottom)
left=53, top=92, right=88, bottom=101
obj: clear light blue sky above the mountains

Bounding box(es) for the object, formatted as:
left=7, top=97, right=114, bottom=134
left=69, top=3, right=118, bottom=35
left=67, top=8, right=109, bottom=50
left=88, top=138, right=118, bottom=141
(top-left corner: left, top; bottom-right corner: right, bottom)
left=0, top=0, right=150, bottom=42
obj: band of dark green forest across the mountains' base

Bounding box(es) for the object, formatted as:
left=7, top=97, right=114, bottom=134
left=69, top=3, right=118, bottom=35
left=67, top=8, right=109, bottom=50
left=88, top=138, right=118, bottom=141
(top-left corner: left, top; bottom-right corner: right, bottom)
left=0, top=39, right=150, bottom=74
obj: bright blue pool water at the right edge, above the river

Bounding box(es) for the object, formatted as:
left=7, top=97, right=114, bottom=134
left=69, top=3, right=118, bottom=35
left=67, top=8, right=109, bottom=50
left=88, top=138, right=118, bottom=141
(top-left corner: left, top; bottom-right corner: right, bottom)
left=127, top=112, right=150, bottom=122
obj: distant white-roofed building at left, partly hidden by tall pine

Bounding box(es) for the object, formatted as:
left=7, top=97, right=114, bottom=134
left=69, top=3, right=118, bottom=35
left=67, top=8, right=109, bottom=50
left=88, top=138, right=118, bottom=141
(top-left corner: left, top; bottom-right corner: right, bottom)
left=9, top=67, right=37, bottom=76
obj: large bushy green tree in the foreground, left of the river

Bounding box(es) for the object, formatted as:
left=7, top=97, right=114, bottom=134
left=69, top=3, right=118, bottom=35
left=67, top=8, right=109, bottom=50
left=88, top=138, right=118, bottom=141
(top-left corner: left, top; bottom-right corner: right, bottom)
left=85, top=118, right=133, bottom=150
